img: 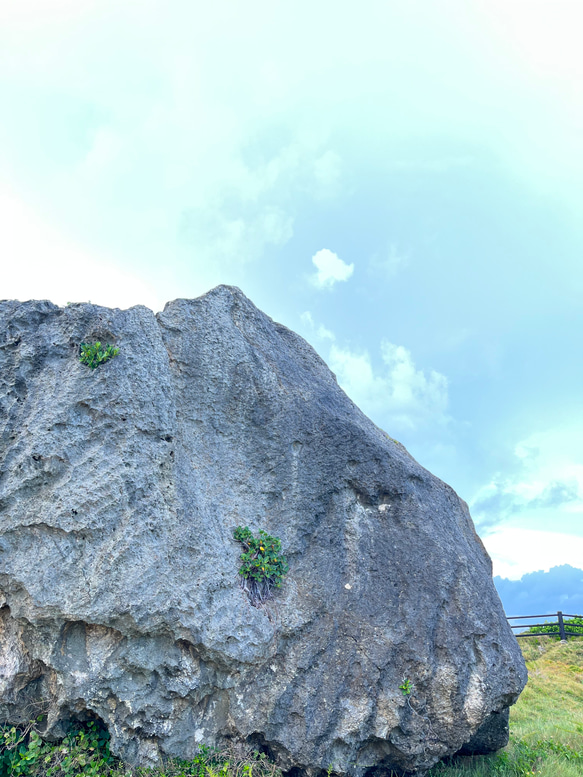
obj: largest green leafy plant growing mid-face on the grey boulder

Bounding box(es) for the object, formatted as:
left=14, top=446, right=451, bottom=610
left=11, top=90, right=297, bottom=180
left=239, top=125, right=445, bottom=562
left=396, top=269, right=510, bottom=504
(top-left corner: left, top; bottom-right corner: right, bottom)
left=233, top=526, right=289, bottom=604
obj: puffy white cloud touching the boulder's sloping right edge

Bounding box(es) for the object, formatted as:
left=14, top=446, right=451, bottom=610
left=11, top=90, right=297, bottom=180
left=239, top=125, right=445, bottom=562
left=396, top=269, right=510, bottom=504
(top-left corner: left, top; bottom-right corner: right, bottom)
left=329, top=340, right=448, bottom=433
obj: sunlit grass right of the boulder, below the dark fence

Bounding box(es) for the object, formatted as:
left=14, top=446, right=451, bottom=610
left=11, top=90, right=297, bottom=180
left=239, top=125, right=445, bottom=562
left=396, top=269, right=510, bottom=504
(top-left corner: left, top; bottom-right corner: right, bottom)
left=427, top=636, right=583, bottom=777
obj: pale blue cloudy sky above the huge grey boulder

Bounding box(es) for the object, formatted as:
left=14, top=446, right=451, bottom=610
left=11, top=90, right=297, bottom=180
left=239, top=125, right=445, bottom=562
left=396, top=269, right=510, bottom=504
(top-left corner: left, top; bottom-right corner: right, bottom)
left=0, top=0, right=583, bottom=609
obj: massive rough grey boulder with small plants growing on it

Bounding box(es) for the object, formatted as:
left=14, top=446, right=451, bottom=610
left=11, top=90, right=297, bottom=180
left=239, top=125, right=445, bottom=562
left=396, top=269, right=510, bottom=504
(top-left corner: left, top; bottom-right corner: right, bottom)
left=0, top=286, right=526, bottom=775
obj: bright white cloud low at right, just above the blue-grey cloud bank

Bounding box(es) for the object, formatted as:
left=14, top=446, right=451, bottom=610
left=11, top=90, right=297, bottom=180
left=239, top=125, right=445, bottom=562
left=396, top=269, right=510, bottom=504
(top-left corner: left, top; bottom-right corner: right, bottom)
left=482, top=526, right=583, bottom=580
